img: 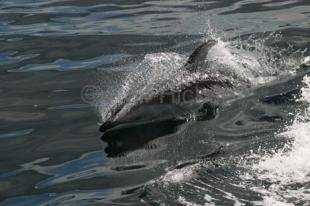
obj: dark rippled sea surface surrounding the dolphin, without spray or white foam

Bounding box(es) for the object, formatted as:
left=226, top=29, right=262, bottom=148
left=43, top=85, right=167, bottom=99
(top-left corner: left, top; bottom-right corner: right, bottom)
left=0, top=0, right=310, bottom=206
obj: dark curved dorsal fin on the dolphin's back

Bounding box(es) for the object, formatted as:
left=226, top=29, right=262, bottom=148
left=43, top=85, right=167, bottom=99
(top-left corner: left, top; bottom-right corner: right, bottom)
left=184, top=39, right=217, bottom=72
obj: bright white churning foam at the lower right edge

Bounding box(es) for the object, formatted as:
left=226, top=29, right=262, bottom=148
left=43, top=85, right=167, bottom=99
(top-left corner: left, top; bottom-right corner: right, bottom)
left=243, top=76, right=310, bottom=205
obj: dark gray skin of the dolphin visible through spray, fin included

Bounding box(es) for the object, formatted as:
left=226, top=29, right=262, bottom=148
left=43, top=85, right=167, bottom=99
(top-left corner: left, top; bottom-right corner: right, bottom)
left=100, top=40, right=232, bottom=132
